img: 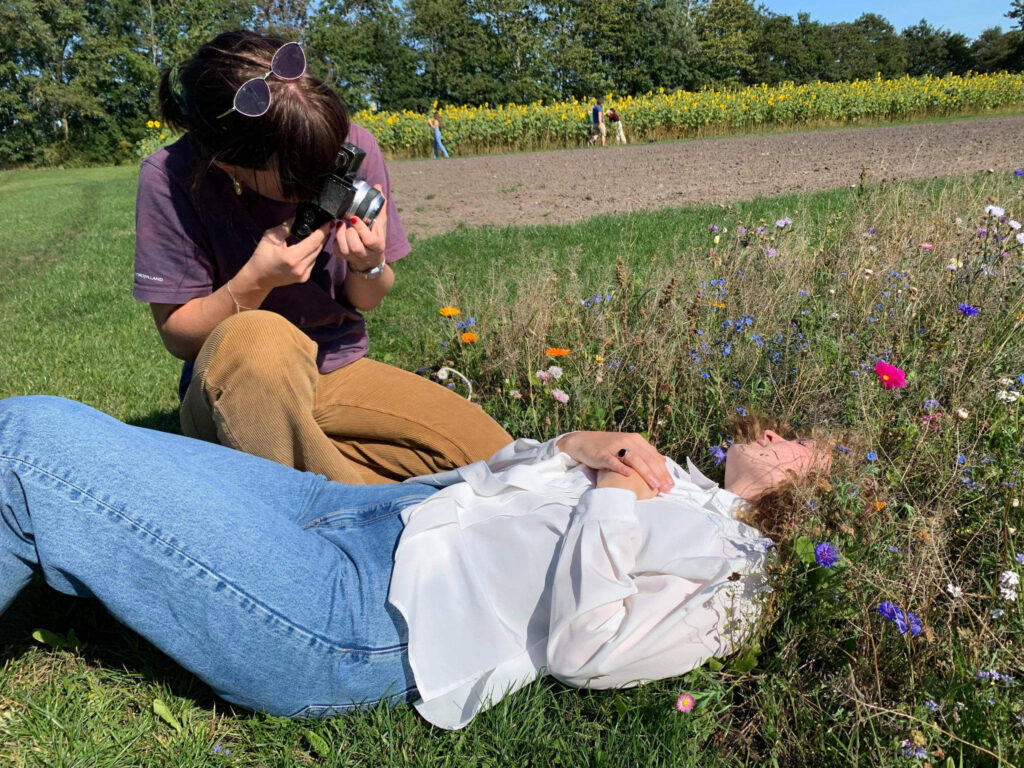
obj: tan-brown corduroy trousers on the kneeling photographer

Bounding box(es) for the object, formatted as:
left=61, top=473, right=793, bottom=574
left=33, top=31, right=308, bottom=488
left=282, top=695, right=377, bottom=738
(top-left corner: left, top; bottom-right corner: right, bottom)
left=181, top=310, right=512, bottom=484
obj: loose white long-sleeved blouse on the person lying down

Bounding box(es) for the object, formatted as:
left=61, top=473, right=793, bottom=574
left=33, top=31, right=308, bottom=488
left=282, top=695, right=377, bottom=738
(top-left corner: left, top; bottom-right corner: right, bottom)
left=389, top=438, right=771, bottom=729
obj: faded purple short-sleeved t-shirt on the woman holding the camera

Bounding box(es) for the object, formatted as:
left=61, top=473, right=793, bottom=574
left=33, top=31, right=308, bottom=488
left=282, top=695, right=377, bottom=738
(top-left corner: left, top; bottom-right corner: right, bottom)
left=132, top=123, right=410, bottom=383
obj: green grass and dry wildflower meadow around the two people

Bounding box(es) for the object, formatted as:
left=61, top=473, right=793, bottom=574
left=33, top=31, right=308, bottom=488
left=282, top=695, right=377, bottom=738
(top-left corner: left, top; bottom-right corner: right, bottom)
left=0, top=163, right=1024, bottom=768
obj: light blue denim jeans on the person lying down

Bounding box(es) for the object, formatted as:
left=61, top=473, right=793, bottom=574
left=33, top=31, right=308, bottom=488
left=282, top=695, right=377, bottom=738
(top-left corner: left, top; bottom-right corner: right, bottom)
left=0, top=396, right=435, bottom=717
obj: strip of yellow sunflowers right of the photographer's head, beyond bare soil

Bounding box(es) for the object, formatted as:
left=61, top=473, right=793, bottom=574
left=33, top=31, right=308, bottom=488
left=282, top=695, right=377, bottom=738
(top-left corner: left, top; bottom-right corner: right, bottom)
left=353, top=73, right=1024, bottom=158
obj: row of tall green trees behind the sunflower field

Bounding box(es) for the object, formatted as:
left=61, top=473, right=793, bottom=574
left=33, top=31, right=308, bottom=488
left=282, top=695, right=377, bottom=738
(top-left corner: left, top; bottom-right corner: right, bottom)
left=6, top=0, right=1024, bottom=166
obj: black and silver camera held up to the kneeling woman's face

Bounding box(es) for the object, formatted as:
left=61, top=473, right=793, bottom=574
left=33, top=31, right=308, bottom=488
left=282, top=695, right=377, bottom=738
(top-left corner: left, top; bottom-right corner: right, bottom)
left=292, top=141, right=385, bottom=240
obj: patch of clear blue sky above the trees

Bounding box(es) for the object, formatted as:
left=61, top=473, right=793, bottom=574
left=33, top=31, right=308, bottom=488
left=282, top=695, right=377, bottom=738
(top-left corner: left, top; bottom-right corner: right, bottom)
left=761, top=0, right=1014, bottom=40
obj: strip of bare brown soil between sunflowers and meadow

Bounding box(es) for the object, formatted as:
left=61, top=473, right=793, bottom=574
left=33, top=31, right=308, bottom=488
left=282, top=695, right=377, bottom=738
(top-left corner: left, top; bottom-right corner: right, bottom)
left=388, top=116, right=1024, bottom=237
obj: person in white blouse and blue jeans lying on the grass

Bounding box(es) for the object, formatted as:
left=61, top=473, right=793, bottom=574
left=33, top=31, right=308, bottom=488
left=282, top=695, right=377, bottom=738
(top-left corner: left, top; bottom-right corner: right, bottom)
left=0, top=397, right=826, bottom=728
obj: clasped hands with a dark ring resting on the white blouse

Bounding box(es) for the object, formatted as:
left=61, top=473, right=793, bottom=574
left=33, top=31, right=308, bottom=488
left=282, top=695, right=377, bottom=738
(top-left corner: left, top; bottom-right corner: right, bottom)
left=557, top=432, right=674, bottom=499
